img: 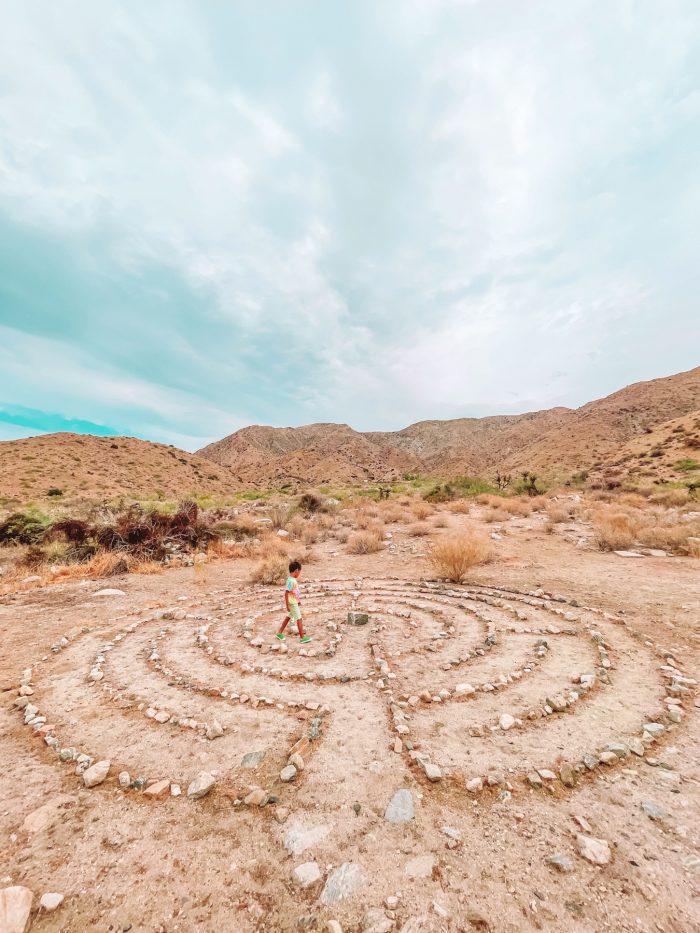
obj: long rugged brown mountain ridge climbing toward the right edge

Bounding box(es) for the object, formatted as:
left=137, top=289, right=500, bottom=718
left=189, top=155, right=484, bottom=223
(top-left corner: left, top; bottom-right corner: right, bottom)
left=198, top=367, right=700, bottom=486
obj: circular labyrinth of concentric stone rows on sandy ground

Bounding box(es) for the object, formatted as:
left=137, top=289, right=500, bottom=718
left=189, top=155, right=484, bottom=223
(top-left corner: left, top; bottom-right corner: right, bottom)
left=10, top=579, right=696, bottom=806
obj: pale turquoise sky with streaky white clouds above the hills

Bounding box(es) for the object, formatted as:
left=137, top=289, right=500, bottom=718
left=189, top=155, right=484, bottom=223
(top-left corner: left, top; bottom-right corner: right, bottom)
left=0, top=0, right=700, bottom=450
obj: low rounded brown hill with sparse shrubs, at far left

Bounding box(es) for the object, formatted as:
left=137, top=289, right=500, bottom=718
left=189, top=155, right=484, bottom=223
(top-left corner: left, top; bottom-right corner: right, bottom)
left=0, top=433, right=241, bottom=500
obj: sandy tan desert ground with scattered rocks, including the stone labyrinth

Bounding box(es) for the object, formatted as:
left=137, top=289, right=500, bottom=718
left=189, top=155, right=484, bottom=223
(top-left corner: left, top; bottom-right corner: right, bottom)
left=0, top=497, right=700, bottom=933
